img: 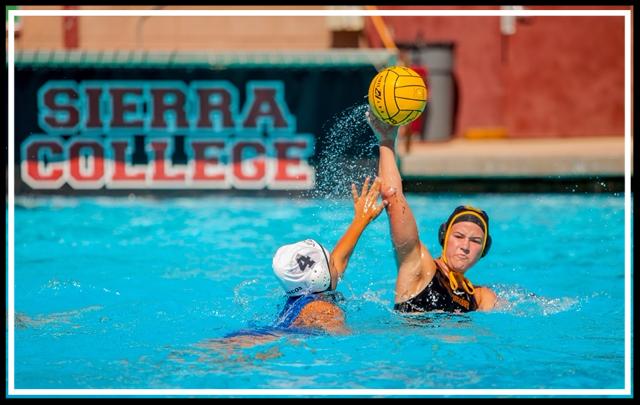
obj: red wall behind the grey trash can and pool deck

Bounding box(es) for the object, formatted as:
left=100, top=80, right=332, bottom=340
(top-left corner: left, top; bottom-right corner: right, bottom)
left=366, top=7, right=625, bottom=138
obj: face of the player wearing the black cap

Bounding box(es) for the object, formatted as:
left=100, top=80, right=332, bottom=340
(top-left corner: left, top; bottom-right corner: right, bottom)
left=446, top=222, right=484, bottom=273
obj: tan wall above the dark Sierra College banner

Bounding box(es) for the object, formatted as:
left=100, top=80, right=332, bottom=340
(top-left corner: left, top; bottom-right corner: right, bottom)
left=16, top=6, right=331, bottom=51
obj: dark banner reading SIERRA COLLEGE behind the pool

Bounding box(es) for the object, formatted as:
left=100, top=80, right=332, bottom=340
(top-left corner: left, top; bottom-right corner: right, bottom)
left=15, top=65, right=376, bottom=194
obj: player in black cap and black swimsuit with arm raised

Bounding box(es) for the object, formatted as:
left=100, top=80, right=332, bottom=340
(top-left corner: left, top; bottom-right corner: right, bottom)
left=366, top=105, right=497, bottom=312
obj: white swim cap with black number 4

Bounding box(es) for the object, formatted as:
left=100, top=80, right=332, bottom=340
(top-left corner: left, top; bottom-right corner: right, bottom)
left=273, top=239, right=331, bottom=297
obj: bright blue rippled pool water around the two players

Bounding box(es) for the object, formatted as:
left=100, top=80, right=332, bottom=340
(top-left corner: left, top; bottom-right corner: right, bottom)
left=15, top=194, right=625, bottom=389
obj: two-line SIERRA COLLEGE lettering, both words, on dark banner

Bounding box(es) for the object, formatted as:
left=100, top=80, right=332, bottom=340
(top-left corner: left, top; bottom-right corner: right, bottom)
left=20, top=80, right=315, bottom=190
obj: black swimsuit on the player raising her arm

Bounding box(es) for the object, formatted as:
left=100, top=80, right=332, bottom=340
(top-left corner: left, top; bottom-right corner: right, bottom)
left=393, top=264, right=478, bottom=312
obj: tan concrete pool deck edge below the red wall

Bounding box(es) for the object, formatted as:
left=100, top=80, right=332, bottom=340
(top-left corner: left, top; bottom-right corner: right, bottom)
left=397, top=136, right=633, bottom=191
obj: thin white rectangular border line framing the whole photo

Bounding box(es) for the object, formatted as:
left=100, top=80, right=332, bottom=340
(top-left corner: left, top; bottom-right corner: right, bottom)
left=7, top=10, right=631, bottom=396
